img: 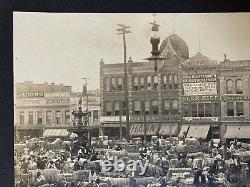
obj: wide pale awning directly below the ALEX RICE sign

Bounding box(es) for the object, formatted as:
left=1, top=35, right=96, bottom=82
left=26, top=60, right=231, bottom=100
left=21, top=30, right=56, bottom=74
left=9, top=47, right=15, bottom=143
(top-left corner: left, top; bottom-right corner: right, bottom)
left=187, top=125, right=210, bottom=139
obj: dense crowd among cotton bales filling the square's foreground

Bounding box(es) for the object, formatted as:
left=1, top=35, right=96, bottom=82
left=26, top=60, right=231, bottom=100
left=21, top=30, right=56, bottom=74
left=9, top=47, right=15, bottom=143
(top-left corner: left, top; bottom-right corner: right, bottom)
left=15, top=134, right=250, bottom=187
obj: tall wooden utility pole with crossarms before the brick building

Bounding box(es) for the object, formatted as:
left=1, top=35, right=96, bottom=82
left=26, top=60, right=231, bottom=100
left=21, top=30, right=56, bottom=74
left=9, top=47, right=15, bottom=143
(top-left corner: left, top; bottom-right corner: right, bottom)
left=116, top=24, right=131, bottom=141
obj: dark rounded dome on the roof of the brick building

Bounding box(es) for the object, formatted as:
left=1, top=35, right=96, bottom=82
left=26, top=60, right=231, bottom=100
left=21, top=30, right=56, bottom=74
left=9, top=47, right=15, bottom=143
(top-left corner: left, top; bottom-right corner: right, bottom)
left=160, top=34, right=189, bottom=60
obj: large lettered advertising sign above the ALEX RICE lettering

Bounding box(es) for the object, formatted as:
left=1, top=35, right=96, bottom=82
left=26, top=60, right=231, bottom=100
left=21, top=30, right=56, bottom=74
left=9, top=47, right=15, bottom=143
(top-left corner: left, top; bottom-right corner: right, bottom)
left=183, top=74, right=217, bottom=95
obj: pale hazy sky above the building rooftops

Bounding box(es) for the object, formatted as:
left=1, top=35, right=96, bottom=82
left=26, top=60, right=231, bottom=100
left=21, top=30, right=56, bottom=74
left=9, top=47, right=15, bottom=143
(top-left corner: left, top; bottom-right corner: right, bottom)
left=13, top=12, right=250, bottom=91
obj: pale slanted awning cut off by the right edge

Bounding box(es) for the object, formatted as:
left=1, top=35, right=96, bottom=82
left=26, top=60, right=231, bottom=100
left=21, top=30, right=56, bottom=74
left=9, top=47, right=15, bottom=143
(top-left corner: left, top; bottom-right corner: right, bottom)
left=224, top=125, right=250, bottom=139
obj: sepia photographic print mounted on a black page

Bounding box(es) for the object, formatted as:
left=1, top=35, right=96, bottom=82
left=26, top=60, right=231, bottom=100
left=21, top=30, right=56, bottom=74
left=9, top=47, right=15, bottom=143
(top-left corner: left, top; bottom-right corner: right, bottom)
left=13, top=11, right=250, bottom=187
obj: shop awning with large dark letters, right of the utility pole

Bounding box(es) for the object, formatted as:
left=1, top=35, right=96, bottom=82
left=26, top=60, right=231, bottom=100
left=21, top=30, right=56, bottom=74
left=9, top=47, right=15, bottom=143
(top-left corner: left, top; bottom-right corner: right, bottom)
left=130, top=123, right=160, bottom=136
